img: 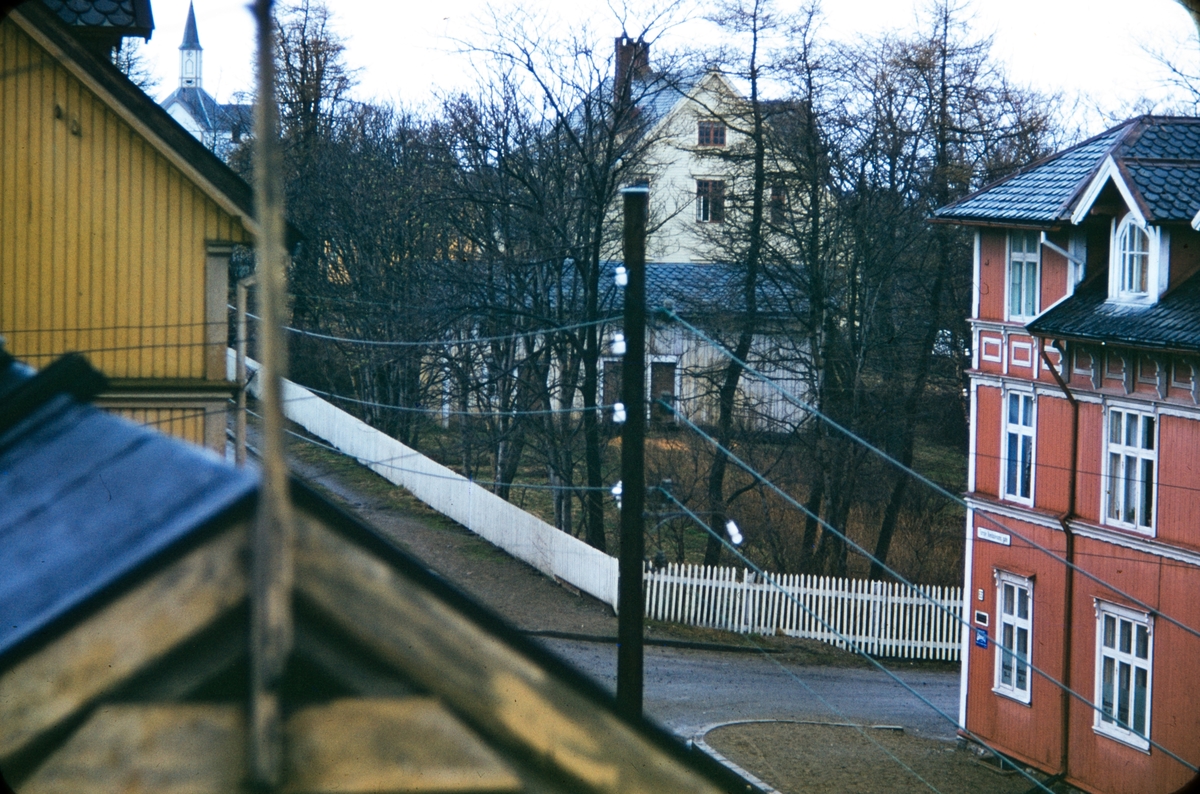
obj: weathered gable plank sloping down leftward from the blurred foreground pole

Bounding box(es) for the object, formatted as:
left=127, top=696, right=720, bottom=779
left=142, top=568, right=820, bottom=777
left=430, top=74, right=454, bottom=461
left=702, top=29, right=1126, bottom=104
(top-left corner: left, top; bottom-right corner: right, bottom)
left=0, top=524, right=247, bottom=765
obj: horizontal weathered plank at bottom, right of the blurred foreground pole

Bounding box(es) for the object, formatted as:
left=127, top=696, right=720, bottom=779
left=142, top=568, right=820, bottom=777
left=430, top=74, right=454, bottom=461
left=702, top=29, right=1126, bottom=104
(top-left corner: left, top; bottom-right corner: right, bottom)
left=283, top=698, right=522, bottom=794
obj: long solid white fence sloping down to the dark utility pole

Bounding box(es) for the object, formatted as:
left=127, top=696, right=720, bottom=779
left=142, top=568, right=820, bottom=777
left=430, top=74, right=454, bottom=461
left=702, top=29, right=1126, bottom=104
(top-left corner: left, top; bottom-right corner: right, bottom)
left=227, top=350, right=617, bottom=610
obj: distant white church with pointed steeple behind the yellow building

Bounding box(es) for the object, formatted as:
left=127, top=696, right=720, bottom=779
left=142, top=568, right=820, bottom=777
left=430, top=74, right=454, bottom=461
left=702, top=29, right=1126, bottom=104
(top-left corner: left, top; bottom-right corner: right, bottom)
left=160, top=4, right=253, bottom=160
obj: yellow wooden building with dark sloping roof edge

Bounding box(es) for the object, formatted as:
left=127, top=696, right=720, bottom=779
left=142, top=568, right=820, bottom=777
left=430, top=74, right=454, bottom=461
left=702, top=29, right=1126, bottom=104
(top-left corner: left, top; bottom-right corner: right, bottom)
left=0, top=0, right=254, bottom=450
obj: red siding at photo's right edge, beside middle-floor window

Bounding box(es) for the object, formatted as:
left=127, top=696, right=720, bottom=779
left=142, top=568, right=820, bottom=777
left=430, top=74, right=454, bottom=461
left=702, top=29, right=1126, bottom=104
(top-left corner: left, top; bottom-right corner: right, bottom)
left=1156, top=416, right=1200, bottom=554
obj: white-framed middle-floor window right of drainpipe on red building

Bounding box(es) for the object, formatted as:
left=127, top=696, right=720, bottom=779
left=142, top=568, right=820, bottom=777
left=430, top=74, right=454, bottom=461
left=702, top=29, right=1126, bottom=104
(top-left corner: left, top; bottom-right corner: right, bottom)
left=1104, top=408, right=1158, bottom=533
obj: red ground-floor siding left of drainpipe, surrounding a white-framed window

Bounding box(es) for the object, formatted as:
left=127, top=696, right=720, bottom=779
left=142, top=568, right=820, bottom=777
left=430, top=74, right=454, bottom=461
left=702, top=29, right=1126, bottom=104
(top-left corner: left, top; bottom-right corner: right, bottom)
left=967, top=515, right=1066, bottom=771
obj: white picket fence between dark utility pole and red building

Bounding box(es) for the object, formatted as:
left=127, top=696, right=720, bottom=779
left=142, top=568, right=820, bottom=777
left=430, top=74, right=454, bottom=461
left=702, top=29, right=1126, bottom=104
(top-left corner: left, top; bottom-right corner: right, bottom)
left=646, top=564, right=962, bottom=661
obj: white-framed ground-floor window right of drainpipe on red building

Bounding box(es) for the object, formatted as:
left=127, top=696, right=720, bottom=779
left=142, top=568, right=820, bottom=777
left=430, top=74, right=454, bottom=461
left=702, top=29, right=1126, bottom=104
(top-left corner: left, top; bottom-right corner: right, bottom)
left=1093, top=601, right=1154, bottom=750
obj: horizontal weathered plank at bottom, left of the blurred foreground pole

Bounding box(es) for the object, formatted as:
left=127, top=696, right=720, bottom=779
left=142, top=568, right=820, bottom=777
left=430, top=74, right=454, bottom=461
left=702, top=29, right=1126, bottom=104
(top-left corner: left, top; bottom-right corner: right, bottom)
left=20, top=704, right=246, bottom=794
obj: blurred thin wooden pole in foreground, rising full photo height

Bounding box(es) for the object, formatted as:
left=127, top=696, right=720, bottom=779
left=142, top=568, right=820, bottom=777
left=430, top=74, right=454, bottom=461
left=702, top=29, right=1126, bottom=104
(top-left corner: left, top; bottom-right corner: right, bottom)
left=250, top=0, right=293, bottom=790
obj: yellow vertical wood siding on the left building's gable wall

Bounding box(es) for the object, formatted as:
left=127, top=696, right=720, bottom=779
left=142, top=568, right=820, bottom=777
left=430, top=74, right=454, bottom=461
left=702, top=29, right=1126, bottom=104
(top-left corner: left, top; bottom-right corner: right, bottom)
left=0, top=14, right=247, bottom=383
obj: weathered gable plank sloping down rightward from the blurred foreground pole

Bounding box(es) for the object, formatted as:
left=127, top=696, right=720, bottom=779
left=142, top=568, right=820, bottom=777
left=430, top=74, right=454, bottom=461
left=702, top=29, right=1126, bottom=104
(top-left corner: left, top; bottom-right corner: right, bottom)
left=295, top=515, right=718, bottom=792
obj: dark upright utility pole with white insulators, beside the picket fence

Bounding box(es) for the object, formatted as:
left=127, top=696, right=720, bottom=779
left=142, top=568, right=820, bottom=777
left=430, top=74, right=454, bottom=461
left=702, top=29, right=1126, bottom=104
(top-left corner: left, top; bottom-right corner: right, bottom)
left=617, top=187, right=650, bottom=718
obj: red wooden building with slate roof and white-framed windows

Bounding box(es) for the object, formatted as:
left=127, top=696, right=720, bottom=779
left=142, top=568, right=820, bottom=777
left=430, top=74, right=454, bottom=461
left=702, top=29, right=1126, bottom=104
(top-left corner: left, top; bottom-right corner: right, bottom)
left=935, top=116, right=1200, bottom=794
